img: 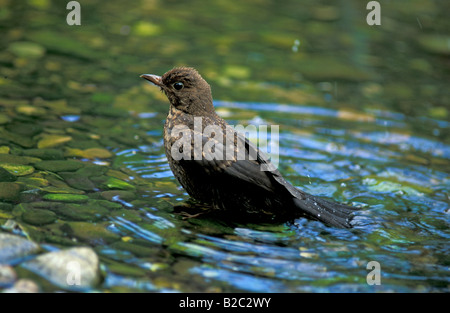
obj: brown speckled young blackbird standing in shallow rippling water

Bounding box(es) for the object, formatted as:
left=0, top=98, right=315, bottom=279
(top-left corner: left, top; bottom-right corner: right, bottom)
left=141, top=67, right=357, bottom=228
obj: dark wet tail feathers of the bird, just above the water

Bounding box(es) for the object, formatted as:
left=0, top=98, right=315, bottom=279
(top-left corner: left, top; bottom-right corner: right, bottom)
left=294, top=194, right=358, bottom=228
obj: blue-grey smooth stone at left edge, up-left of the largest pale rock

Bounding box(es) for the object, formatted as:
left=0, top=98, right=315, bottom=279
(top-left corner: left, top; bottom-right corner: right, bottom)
left=0, top=233, right=39, bottom=264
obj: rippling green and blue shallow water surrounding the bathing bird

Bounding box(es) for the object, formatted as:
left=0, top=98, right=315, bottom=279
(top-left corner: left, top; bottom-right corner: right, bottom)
left=0, top=0, right=450, bottom=292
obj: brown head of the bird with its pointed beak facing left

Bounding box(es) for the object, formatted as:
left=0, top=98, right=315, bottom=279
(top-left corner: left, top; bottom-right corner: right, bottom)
left=141, top=67, right=215, bottom=116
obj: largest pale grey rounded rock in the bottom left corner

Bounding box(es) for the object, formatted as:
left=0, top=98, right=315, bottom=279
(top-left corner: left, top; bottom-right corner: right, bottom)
left=23, top=247, right=100, bottom=290
